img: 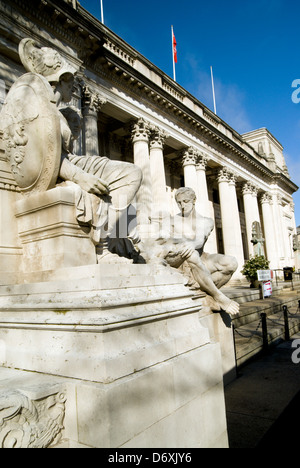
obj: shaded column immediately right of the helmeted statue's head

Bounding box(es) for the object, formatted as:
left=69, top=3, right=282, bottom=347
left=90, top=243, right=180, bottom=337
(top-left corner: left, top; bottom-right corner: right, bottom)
left=82, top=86, right=106, bottom=156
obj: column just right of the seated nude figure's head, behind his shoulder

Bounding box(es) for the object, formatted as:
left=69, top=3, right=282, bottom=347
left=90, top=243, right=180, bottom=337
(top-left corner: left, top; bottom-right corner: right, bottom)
left=196, top=152, right=217, bottom=253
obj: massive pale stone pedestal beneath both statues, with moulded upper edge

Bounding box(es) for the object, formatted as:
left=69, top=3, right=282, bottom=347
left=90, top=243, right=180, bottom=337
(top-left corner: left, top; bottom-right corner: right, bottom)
left=0, top=265, right=228, bottom=448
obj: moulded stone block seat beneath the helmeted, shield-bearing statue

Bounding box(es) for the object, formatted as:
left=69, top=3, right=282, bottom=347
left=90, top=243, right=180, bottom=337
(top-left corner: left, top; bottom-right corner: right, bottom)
left=15, top=186, right=96, bottom=274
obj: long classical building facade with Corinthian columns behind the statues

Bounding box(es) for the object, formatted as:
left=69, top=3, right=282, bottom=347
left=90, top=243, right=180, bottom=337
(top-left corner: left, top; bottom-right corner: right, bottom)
left=0, top=0, right=298, bottom=278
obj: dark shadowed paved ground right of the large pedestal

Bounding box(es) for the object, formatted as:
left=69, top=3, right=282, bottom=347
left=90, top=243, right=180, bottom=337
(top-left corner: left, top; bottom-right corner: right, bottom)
left=225, top=334, right=300, bottom=448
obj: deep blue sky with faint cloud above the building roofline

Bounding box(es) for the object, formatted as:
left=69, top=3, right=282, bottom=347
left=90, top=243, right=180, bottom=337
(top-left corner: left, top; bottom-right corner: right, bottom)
left=80, top=0, right=300, bottom=225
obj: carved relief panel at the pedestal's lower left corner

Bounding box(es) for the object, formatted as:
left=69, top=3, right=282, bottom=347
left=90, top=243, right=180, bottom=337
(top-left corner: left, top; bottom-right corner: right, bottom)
left=0, top=368, right=67, bottom=448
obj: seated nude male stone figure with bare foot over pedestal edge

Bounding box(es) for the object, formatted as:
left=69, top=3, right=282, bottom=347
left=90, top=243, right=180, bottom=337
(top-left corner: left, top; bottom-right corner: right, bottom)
left=139, top=187, right=239, bottom=315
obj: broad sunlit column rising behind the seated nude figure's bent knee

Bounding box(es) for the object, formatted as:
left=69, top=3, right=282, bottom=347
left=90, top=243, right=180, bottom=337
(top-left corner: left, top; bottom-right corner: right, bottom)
left=217, top=168, right=244, bottom=279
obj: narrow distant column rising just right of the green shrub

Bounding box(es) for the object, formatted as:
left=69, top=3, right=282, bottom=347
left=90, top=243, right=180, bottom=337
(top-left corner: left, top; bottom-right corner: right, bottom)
left=260, top=192, right=278, bottom=269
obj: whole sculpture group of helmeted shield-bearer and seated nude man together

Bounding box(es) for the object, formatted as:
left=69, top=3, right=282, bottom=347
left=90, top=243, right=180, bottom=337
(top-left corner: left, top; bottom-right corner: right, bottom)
left=1, top=38, right=239, bottom=315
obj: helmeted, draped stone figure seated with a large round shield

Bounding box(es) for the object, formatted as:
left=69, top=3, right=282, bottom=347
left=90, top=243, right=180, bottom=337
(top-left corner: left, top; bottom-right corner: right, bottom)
left=1, top=38, right=142, bottom=263
